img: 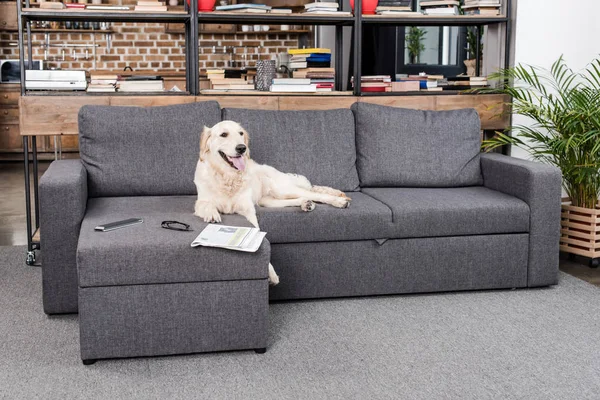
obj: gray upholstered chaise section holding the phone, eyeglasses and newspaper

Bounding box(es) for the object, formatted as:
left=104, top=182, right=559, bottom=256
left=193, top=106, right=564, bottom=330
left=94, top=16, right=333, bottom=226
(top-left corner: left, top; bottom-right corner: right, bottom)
left=77, top=196, right=270, bottom=364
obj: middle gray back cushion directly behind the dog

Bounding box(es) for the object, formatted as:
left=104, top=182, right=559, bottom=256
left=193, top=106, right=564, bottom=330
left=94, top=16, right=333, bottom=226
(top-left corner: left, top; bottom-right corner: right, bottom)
left=223, top=108, right=359, bottom=191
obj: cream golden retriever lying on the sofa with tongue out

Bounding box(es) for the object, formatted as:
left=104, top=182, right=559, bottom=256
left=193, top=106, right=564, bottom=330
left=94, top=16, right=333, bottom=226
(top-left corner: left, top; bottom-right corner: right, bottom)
left=194, top=121, right=350, bottom=285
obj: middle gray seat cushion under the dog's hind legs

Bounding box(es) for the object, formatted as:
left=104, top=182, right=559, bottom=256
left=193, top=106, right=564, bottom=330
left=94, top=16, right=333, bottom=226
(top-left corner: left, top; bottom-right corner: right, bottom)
left=257, top=192, right=392, bottom=243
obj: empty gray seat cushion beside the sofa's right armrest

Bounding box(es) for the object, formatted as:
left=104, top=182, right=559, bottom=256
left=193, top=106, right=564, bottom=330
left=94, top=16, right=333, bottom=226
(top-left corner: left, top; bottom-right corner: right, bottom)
left=362, top=186, right=529, bottom=238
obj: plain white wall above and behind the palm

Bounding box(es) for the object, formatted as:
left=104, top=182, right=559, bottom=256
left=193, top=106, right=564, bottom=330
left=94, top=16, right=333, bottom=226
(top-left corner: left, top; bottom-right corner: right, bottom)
left=512, top=0, right=600, bottom=158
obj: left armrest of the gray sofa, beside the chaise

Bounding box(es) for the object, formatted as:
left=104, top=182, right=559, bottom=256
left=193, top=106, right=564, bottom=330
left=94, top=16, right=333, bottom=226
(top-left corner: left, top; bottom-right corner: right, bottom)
left=39, top=160, right=88, bottom=314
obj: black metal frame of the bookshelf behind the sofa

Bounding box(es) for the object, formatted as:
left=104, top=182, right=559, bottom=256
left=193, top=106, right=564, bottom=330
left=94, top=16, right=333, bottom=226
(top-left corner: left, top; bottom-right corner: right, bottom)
left=17, top=0, right=512, bottom=265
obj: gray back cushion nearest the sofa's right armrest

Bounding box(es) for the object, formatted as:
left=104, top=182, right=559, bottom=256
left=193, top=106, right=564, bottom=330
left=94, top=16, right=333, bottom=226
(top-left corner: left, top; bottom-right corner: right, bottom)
left=352, top=102, right=483, bottom=187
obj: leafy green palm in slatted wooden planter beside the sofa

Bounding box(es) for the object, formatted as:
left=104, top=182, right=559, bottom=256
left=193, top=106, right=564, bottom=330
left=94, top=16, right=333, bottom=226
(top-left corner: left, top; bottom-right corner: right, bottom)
left=483, top=57, right=600, bottom=267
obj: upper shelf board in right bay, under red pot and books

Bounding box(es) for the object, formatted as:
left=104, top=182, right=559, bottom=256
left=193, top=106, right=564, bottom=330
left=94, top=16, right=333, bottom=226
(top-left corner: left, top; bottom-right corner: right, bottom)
left=363, top=15, right=508, bottom=26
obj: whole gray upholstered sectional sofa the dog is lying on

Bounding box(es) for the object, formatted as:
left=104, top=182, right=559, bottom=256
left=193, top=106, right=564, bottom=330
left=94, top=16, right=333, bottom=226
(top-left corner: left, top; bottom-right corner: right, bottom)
left=40, top=102, right=561, bottom=316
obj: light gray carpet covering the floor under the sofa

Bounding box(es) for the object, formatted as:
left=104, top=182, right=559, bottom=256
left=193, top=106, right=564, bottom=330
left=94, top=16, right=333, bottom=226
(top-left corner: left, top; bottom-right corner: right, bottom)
left=0, top=247, right=600, bottom=400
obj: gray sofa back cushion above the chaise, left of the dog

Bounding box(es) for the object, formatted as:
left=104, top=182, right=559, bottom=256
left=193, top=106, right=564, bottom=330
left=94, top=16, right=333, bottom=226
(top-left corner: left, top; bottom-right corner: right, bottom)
left=79, top=101, right=221, bottom=197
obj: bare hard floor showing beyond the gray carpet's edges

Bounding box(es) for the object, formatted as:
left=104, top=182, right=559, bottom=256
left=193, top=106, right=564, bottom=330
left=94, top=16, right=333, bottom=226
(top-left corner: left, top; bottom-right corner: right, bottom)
left=0, top=162, right=600, bottom=286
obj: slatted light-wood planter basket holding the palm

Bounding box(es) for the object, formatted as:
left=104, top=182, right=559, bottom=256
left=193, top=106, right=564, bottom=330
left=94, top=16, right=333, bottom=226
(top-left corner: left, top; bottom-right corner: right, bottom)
left=560, top=198, right=600, bottom=267
